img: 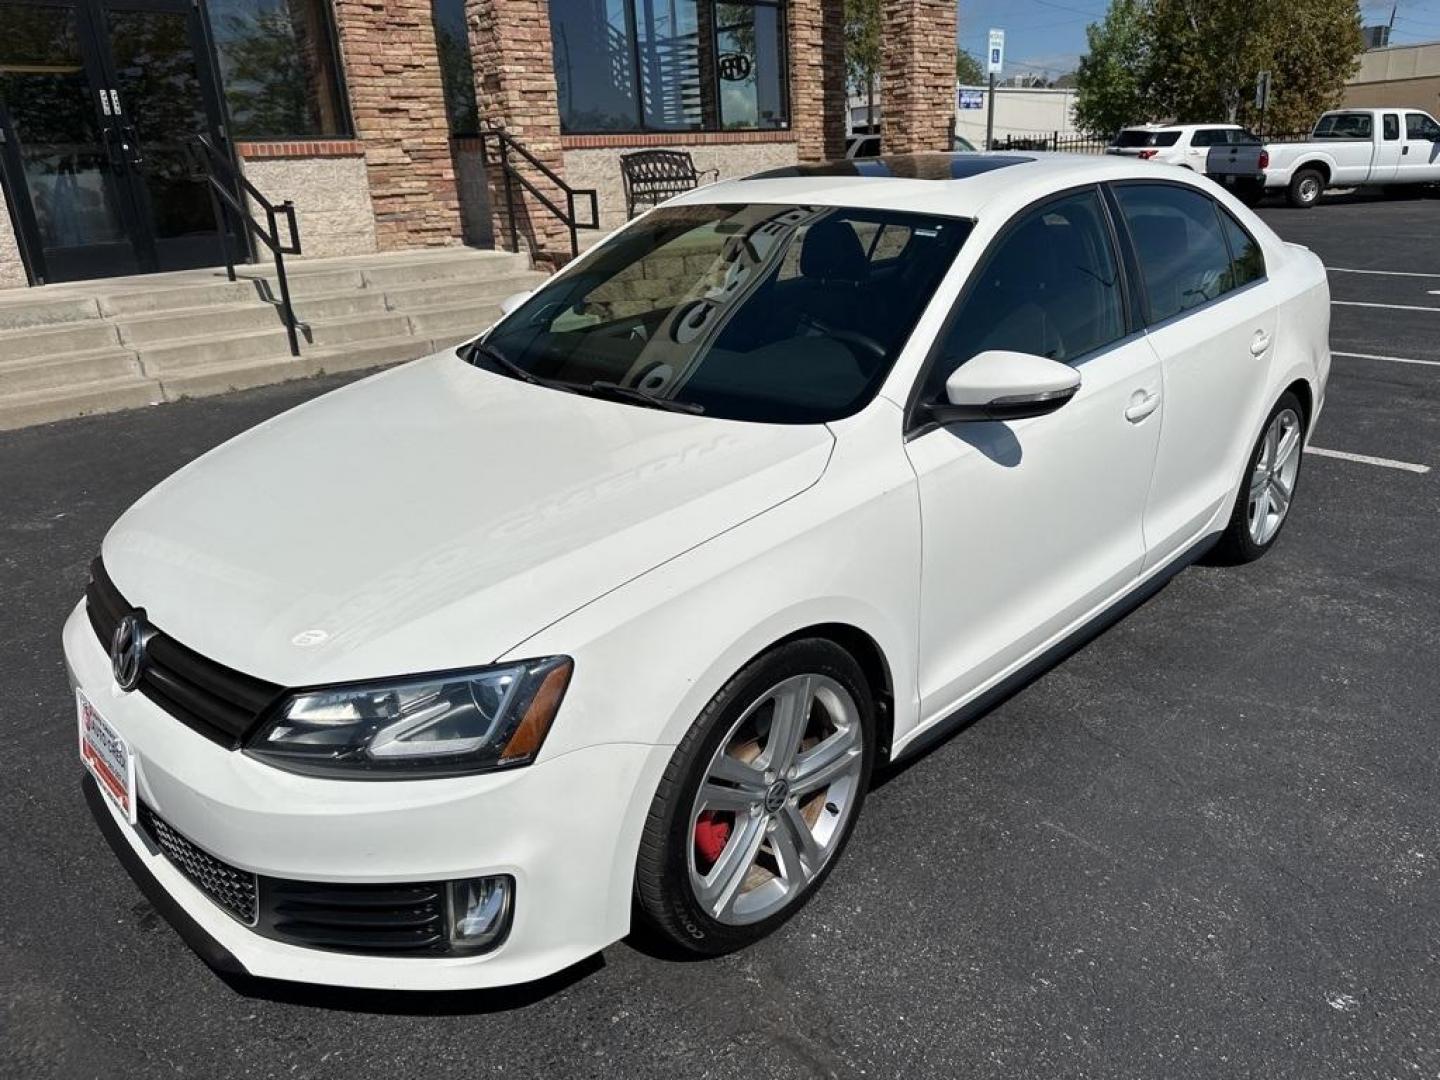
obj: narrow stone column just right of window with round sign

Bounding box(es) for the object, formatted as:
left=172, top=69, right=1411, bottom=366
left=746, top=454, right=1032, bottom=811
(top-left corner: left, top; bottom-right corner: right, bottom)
left=786, top=0, right=840, bottom=161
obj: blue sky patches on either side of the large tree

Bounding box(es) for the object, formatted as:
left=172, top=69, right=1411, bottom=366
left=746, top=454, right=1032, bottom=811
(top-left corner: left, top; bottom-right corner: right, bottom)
left=959, top=0, right=1440, bottom=78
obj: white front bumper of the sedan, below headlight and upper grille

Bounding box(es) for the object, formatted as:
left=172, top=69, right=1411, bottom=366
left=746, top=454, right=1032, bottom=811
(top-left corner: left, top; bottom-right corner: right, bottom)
left=63, top=602, right=671, bottom=989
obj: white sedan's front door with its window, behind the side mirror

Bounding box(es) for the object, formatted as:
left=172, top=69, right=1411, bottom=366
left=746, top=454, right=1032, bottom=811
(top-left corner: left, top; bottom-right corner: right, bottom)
left=906, top=186, right=1162, bottom=716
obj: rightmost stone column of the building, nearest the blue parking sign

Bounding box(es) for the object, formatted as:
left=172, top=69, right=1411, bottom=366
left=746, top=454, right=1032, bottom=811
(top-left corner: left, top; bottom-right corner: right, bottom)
left=880, top=0, right=955, bottom=154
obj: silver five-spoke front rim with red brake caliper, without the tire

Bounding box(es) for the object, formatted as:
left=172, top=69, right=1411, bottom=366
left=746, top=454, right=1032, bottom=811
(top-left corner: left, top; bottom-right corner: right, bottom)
left=687, top=674, right=864, bottom=926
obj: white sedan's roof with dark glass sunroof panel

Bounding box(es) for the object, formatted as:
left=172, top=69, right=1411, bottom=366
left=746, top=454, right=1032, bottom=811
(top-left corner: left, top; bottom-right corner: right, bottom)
left=668, top=153, right=1197, bottom=217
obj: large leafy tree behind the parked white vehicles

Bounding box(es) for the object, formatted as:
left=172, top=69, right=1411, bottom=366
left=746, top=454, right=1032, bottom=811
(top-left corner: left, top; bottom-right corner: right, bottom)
left=1076, top=0, right=1364, bottom=134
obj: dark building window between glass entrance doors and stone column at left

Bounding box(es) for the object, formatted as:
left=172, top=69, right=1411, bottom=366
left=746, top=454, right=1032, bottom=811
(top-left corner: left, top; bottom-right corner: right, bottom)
left=207, top=0, right=350, bottom=138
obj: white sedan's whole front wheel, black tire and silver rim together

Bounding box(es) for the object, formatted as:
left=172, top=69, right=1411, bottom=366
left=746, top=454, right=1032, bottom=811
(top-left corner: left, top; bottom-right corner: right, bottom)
left=635, top=638, right=876, bottom=956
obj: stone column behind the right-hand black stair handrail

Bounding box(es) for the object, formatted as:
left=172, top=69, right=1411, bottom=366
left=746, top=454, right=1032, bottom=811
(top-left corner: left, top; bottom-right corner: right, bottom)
left=465, top=0, right=567, bottom=264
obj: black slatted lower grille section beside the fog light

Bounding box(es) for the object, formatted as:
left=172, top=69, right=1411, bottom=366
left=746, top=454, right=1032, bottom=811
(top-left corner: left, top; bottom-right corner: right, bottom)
left=256, top=878, right=448, bottom=955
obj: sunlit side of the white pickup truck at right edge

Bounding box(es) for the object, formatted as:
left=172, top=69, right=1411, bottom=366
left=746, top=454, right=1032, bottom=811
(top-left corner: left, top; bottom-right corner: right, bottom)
left=1263, top=109, right=1440, bottom=207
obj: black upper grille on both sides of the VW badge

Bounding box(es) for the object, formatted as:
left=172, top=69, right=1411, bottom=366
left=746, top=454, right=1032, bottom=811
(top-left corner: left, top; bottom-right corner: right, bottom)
left=85, top=559, right=282, bottom=749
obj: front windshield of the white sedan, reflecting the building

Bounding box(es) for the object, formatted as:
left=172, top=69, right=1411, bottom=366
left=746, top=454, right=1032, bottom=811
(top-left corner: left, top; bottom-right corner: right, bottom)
left=471, top=204, right=971, bottom=423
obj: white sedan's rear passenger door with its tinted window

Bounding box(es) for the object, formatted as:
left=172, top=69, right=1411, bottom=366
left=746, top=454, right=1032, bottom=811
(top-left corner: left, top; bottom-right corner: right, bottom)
left=1112, top=181, right=1276, bottom=569
